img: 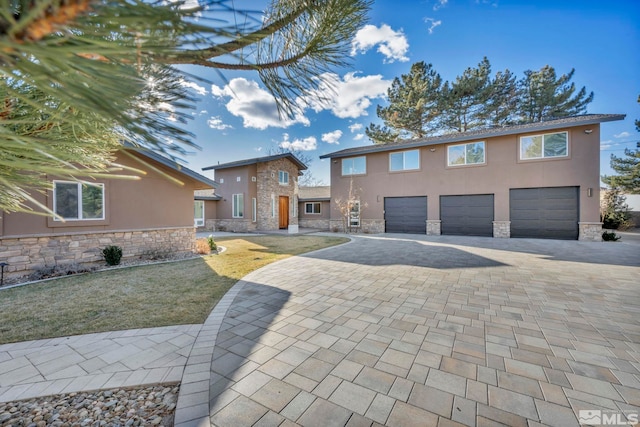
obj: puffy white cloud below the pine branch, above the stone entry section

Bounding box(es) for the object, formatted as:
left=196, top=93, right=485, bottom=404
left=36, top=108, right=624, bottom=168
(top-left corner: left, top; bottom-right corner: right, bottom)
left=211, top=78, right=310, bottom=130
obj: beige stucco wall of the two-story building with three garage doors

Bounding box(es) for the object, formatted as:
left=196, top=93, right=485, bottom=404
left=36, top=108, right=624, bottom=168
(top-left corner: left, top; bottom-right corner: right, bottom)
left=331, top=125, right=600, bottom=222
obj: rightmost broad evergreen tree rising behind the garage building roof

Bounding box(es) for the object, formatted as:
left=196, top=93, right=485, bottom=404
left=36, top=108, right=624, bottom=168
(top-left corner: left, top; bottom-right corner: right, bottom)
left=519, top=65, right=593, bottom=123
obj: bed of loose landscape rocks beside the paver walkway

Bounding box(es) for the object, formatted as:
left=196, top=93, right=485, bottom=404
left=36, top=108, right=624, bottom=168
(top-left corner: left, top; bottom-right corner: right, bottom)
left=0, top=384, right=180, bottom=427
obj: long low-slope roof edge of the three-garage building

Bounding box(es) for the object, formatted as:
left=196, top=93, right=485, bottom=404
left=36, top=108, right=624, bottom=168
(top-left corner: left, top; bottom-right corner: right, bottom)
left=320, top=114, right=626, bottom=159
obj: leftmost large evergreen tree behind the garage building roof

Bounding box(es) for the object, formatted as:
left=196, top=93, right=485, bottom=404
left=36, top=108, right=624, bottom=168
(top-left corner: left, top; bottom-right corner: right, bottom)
left=366, top=62, right=442, bottom=143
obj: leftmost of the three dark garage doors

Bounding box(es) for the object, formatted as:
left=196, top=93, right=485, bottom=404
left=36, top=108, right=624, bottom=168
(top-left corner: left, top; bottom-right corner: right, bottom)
left=384, top=196, right=427, bottom=234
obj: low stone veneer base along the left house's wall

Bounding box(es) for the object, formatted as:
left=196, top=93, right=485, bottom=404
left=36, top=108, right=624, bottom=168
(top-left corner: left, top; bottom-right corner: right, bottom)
left=0, top=227, right=196, bottom=278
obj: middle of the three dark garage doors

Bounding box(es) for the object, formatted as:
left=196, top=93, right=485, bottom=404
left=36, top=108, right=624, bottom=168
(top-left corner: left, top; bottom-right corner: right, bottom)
left=440, top=194, right=493, bottom=237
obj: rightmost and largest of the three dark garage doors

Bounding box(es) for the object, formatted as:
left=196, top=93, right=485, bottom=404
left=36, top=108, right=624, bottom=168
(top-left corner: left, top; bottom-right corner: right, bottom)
left=509, top=187, right=579, bottom=240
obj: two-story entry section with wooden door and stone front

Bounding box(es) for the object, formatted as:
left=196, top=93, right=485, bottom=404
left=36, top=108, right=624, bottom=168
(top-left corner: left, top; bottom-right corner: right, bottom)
left=202, top=153, right=307, bottom=233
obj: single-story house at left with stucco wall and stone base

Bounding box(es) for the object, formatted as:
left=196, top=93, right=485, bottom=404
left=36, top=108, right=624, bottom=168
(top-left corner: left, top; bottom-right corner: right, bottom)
left=0, top=147, right=217, bottom=277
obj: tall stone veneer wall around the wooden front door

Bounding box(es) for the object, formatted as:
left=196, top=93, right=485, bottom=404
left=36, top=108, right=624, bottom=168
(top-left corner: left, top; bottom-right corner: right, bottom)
left=256, top=158, right=298, bottom=230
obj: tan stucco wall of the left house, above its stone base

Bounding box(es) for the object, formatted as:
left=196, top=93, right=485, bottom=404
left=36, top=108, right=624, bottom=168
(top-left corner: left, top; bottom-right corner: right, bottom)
left=2, top=150, right=202, bottom=237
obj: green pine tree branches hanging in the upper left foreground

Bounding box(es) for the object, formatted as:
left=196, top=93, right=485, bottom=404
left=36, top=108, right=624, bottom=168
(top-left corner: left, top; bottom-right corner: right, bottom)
left=0, top=0, right=371, bottom=211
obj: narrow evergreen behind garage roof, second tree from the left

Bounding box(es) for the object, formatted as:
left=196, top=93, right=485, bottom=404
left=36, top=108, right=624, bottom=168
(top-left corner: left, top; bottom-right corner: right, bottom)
left=442, top=57, right=492, bottom=132
